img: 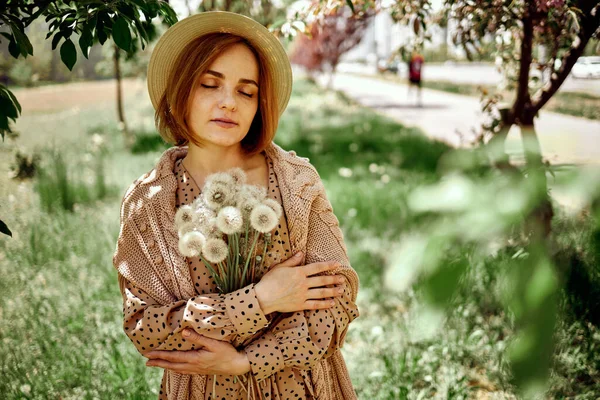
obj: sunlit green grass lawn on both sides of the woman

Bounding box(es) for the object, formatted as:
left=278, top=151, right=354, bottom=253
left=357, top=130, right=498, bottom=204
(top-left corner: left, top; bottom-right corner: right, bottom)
left=0, top=76, right=600, bottom=400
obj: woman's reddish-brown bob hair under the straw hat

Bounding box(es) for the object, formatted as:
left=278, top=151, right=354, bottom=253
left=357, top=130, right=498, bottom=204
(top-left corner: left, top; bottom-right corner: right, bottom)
left=154, top=33, right=279, bottom=155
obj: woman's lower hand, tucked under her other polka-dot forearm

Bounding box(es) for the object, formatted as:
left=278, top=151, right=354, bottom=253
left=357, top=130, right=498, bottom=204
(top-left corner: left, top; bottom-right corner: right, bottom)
left=145, top=329, right=250, bottom=375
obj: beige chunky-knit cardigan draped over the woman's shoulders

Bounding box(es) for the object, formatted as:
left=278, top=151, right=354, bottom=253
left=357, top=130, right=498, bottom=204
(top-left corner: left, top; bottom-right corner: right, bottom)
left=113, top=143, right=359, bottom=400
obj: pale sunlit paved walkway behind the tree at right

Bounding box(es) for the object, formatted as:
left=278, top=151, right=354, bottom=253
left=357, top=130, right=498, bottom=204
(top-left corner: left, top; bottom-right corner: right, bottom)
left=321, top=73, right=600, bottom=164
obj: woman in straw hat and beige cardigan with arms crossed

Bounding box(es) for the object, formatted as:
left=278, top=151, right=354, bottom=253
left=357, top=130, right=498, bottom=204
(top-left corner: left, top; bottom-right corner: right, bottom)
left=113, top=12, right=358, bottom=400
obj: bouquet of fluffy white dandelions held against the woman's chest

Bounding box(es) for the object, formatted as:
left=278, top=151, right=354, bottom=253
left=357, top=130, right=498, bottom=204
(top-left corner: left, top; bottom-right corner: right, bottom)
left=175, top=168, right=282, bottom=293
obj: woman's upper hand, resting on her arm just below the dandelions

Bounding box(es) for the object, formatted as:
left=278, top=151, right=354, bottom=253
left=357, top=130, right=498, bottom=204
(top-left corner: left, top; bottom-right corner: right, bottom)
left=254, top=253, right=346, bottom=314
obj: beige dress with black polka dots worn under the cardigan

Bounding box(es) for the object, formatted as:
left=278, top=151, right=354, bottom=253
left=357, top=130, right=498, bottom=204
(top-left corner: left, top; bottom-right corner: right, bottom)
left=119, top=152, right=358, bottom=400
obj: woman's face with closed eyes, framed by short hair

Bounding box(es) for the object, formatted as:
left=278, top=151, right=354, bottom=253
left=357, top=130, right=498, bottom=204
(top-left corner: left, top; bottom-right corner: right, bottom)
left=187, top=44, right=258, bottom=147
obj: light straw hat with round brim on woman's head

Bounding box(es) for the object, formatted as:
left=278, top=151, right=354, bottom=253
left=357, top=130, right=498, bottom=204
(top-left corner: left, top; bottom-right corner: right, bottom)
left=148, top=11, right=292, bottom=115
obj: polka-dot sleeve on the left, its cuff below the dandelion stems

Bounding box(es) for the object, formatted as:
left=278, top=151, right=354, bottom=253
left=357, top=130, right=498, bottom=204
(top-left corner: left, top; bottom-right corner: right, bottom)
left=115, top=222, right=269, bottom=354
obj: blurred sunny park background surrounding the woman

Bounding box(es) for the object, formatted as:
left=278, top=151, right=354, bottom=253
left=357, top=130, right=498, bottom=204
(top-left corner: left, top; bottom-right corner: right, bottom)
left=0, top=0, right=600, bottom=399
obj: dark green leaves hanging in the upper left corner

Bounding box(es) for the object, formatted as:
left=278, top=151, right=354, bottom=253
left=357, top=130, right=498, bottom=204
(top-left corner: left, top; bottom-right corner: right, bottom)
left=0, top=0, right=177, bottom=141
